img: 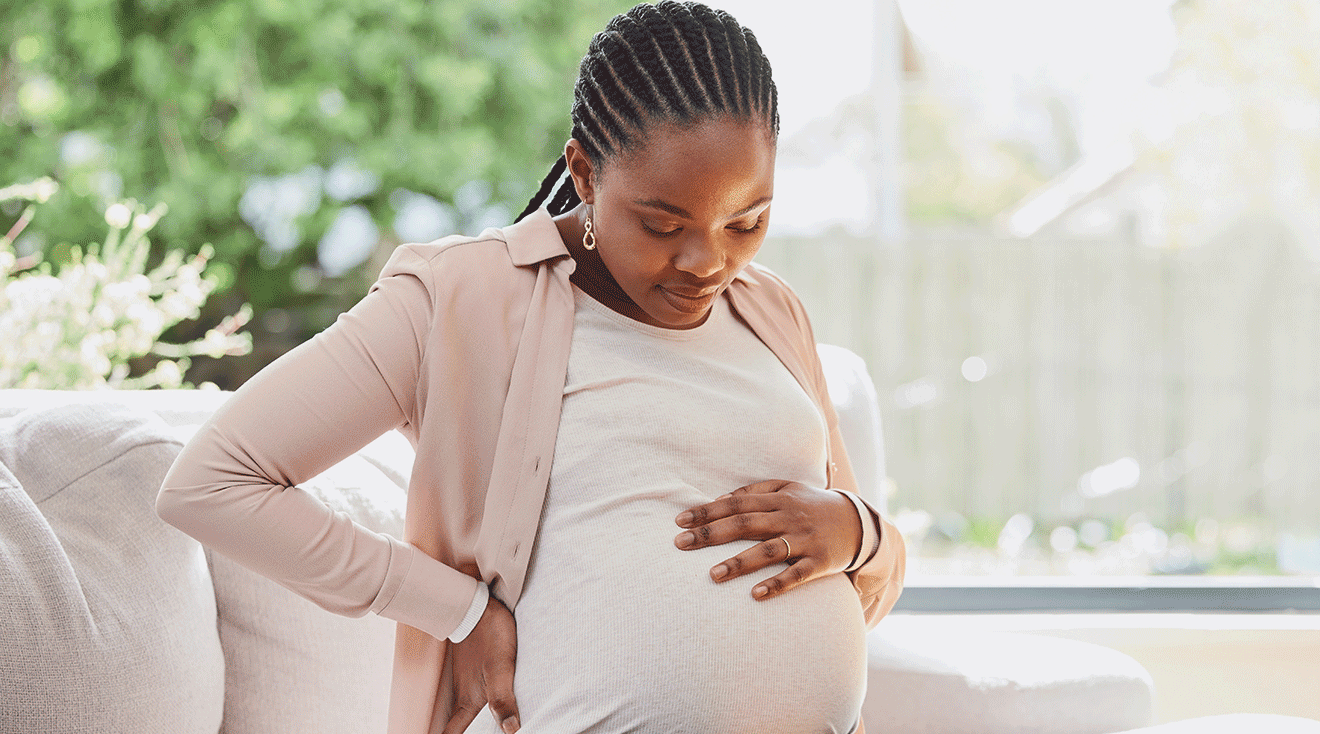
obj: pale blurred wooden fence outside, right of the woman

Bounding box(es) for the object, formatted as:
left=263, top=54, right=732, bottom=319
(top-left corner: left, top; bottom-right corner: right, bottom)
left=759, top=217, right=1320, bottom=535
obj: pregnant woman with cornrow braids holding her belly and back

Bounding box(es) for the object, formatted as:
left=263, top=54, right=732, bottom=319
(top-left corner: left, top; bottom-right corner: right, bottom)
left=157, top=0, right=904, bottom=734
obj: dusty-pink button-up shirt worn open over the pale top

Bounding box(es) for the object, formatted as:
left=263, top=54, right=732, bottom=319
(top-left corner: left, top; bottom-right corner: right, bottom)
left=156, top=209, right=904, bottom=734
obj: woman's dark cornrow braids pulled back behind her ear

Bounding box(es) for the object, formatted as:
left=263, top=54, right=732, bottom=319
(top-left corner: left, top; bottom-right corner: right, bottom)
left=517, top=0, right=779, bottom=219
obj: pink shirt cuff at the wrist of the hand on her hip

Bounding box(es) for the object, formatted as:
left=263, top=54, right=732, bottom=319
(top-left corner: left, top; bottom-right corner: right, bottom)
left=372, top=537, right=486, bottom=642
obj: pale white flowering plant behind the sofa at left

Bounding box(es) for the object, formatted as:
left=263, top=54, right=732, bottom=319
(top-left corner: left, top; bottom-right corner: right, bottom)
left=0, top=178, right=252, bottom=389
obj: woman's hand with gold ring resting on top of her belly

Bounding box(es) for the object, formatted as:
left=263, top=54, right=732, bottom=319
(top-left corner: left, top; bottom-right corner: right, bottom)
left=675, top=481, right=862, bottom=601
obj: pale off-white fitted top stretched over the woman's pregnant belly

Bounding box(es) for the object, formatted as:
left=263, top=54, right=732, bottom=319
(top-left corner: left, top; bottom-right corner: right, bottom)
left=467, top=290, right=866, bottom=734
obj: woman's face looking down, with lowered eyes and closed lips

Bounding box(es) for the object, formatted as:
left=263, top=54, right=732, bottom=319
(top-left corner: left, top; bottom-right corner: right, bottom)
left=569, top=117, right=775, bottom=329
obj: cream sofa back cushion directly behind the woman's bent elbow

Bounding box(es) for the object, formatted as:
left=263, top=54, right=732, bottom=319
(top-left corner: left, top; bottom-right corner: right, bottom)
left=178, top=426, right=413, bottom=734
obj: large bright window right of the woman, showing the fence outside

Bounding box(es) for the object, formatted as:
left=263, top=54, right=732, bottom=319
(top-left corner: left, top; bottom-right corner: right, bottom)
left=723, top=0, right=1320, bottom=591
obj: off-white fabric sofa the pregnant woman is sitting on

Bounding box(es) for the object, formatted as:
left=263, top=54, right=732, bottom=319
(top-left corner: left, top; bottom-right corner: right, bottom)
left=0, top=346, right=1320, bottom=734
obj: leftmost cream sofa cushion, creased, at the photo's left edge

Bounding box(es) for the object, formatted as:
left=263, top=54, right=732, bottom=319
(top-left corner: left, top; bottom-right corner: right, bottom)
left=0, top=403, right=224, bottom=734
